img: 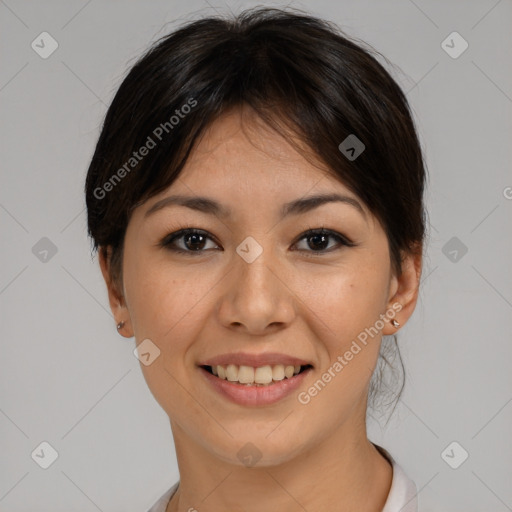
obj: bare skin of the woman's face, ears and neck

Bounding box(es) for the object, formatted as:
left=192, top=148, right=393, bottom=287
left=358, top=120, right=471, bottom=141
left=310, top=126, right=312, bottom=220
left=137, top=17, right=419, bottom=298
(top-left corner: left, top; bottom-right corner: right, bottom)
left=100, top=109, right=421, bottom=512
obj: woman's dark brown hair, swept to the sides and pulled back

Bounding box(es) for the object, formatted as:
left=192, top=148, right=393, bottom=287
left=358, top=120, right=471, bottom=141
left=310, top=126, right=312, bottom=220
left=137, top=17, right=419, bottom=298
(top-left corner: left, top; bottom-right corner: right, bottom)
left=85, top=7, right=426, bottom=418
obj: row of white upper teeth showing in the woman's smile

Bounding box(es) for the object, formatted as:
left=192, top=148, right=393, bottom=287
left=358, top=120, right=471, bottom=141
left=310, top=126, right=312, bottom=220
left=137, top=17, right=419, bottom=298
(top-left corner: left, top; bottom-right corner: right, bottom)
left=207, top=364, right=300, bottom=385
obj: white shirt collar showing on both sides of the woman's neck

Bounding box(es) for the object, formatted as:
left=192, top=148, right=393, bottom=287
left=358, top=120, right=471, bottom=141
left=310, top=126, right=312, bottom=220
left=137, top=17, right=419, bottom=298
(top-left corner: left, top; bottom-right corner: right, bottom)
left=147, top=443, right=418, bottom=512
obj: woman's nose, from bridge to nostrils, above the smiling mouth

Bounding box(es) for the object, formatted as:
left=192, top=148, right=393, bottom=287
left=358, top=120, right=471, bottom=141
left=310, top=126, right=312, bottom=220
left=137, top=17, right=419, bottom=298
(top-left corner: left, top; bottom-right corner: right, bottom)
left=218, top=247, right=296, bottom=336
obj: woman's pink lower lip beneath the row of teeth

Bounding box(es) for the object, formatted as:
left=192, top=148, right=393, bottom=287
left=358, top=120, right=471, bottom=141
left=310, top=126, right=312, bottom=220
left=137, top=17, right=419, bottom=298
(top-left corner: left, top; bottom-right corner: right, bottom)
left=199, top=367, right=312, bottom=405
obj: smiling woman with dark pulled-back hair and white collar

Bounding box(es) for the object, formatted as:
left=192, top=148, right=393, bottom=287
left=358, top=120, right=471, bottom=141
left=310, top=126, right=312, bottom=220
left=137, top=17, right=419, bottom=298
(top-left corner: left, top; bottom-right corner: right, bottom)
left=85, top=8, right=426, bottom=512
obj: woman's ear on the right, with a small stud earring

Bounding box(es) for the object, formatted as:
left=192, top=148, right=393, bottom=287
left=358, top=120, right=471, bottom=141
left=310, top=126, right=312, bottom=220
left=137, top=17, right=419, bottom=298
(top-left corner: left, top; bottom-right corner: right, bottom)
left=382, top=248, right=422, bottom=335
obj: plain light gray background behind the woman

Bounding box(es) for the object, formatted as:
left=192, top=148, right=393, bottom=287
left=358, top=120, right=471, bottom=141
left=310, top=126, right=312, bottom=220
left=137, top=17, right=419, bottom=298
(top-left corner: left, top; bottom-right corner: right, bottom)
left=0, top=0, right=512, bottom=512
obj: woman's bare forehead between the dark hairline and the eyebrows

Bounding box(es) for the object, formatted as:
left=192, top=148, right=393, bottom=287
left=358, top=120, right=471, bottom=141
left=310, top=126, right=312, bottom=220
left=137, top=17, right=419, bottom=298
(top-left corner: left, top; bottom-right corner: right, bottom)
left=180, top=108, right=348, bottom=193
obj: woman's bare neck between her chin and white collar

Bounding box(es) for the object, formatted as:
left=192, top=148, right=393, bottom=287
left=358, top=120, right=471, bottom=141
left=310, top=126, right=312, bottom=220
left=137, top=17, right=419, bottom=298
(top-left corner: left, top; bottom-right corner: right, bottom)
left=166, top=414, right=393, bottom=512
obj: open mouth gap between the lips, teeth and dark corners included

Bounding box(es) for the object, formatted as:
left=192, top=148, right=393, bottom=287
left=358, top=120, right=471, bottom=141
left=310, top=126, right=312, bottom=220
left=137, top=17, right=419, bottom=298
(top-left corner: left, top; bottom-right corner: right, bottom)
left=200, top=364, right=313, bottom=388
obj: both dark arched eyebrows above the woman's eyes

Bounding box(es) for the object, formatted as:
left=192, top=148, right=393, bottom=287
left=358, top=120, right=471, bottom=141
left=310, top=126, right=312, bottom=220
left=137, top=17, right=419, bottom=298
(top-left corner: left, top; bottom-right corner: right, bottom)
left=144, top=194, right=367, bottom=220
